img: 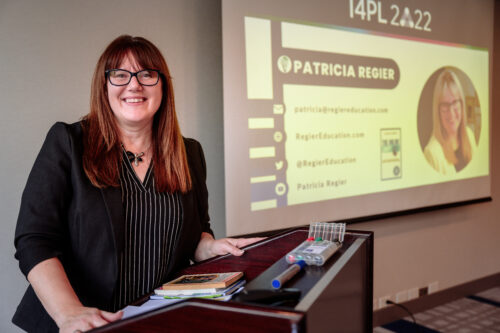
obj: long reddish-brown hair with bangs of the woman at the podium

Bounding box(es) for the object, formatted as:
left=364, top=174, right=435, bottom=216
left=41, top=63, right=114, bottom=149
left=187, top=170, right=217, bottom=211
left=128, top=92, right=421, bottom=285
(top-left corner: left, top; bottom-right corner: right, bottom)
left=82, top=35, right=191, bottom=193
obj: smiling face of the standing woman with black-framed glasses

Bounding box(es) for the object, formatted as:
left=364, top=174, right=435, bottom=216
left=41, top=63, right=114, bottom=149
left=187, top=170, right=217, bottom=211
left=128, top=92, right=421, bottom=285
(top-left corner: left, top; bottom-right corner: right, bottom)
left=107, top=55, right=162, bottom=129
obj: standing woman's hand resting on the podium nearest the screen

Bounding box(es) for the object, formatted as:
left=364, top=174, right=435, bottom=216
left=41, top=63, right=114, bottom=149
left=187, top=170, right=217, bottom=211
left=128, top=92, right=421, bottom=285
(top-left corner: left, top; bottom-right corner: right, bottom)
left=194, top=232, right=264, bottom=261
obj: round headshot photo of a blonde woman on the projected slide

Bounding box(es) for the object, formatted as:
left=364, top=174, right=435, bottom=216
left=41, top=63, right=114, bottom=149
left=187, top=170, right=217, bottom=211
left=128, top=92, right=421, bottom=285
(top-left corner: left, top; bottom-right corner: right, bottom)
left=417, top=66, right=481, bottom=175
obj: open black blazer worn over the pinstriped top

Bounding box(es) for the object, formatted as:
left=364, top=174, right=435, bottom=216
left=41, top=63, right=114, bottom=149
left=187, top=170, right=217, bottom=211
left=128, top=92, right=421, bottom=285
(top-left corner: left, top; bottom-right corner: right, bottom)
left=12, top=122, right=213, bottom=332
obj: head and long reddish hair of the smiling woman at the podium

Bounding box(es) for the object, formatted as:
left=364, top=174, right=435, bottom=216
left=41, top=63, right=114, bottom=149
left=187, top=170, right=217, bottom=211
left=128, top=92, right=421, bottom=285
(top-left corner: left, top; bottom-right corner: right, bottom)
left=83, top=36, right=186, bottom=192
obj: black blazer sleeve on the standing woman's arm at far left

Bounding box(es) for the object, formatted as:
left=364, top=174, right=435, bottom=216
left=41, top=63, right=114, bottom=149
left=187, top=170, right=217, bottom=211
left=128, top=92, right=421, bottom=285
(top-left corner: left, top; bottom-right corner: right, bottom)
left=14, top=123, right=72, bottom=275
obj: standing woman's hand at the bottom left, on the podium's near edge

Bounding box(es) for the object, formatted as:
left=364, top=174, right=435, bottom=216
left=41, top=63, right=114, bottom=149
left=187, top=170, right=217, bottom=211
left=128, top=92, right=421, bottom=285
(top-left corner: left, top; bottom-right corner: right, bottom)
left=56, top=306, right=123, bottom=333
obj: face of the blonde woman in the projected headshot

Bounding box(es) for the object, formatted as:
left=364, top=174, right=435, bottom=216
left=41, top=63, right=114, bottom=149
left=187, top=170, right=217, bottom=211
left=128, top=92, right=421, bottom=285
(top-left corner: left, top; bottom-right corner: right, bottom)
left=439, top=86, right=463, bottom=136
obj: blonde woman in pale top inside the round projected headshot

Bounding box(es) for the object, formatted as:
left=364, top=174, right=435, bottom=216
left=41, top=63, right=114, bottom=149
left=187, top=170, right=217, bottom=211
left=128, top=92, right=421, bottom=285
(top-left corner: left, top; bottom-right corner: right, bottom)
left=424, top=69, right=475, bottom=175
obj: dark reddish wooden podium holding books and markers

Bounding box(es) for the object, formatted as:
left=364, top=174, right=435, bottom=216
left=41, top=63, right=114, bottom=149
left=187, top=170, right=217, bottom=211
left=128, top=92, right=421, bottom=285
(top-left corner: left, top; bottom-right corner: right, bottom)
left=92, top=228, right=373, bottom=333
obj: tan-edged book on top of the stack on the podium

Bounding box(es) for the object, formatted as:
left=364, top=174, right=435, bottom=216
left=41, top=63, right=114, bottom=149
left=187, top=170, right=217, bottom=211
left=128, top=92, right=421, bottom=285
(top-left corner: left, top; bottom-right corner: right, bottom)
left=155, top=272, right=243, bottom=294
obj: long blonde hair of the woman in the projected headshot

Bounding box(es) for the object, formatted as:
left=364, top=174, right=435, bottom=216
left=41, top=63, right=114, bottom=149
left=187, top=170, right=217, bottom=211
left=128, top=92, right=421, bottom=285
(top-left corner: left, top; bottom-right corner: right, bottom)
left=432, top=68, right=472, bottom=164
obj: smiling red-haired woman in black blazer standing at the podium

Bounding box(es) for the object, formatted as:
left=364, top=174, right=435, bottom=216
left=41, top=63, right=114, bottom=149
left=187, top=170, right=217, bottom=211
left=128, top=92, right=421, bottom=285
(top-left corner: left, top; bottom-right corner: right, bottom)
left=13, top=36, right=257, bottom=332
